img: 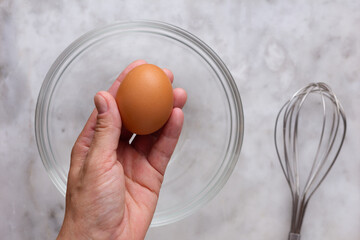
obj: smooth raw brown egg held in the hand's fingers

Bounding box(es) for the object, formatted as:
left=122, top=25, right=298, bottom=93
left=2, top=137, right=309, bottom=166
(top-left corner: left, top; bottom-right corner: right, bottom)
left=116, top=64, right=174, bottom=135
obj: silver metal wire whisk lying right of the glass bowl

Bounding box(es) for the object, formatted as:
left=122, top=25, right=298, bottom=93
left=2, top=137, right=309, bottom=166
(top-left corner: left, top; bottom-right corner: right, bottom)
left=274, top=82, right=346, bottom=240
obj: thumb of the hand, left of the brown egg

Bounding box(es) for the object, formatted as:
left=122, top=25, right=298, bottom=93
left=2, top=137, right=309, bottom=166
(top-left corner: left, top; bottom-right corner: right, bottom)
left=88, top=91, right=121, bottom=165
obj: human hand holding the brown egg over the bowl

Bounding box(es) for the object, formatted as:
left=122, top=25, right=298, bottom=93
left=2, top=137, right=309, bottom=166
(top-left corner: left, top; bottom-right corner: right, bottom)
left=58, top=60, right=187, bottom=240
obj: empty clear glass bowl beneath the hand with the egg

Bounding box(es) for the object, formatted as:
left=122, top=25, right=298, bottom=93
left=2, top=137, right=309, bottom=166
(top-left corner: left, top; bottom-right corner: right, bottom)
left=35, top=21, right=244, bottom=226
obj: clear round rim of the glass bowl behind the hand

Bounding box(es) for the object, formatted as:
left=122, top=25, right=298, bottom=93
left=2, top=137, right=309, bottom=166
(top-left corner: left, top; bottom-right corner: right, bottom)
left=35, top=20, right=244, bottom=226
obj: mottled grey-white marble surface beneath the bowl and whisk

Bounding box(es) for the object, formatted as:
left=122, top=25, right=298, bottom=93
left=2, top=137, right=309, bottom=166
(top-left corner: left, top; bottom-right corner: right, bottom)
left=0, top=0, right=360, bottom=240
